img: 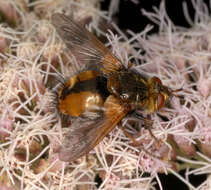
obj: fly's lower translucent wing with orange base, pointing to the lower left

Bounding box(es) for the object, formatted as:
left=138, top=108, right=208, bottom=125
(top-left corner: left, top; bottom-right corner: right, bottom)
left=59, top=96, right=127, bottom=162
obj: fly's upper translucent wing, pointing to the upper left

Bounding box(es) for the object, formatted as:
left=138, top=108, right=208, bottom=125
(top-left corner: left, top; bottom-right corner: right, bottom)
left=51, top=13, right=123, bottom=74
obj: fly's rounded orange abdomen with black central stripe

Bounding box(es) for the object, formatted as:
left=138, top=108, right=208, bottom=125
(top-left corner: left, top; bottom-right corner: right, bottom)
left=58, top=71, right=108, bottom=117
